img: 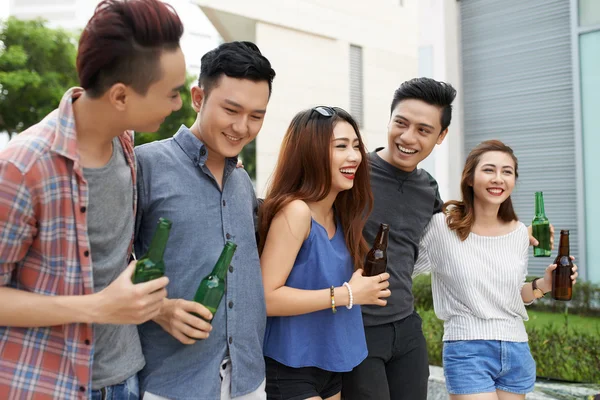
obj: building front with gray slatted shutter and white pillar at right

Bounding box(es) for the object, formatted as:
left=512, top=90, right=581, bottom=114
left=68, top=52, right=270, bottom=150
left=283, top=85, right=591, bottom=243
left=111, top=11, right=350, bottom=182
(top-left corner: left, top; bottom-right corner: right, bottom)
left=419, top=0, right=600, bottom=283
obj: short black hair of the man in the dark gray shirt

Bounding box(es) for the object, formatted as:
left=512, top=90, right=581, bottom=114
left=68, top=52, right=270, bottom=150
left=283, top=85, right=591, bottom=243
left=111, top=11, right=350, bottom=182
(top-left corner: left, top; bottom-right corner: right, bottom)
left=390, top=78, right=456, bottom=132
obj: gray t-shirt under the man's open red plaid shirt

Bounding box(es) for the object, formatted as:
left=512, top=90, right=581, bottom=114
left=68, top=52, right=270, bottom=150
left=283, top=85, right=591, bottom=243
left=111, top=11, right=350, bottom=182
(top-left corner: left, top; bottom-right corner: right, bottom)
left=83, top=138, right=144, bottom=389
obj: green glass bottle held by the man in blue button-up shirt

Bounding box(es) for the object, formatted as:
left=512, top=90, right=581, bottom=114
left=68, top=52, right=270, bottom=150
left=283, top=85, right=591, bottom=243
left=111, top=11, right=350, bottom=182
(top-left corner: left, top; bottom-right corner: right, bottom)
left=194, top=242, right=237, bottom=316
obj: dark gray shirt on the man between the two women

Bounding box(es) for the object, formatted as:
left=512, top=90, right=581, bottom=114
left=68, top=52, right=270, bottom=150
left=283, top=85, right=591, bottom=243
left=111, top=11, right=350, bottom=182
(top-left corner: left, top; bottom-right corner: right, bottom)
left=362, top=148, right=443, bottom=326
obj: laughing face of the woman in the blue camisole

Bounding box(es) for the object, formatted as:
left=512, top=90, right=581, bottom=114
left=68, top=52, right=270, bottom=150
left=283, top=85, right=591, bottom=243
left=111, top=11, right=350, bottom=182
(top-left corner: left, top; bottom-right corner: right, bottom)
left=331, top=120, right=362, bottom=193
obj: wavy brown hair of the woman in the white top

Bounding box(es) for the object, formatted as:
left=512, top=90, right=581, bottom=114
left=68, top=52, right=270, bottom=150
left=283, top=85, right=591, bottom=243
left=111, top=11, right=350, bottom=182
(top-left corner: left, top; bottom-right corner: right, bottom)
left=442, top=140, right=519, bottom=240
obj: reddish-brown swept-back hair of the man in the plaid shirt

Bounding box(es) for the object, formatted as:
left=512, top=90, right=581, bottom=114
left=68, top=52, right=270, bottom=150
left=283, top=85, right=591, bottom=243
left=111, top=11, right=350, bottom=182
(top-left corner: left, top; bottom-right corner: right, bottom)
left=77, top=0, right=183, bottom=97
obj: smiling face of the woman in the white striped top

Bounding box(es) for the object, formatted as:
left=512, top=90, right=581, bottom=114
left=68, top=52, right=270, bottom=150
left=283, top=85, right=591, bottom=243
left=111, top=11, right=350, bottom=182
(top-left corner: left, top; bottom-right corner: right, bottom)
left=472, top=151, right=516, bottom=206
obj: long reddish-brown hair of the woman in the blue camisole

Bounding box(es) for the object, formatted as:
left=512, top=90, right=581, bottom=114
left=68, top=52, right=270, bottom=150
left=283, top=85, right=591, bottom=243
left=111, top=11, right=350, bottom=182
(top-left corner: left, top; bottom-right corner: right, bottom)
left=258, top=108, right=373, bottom=269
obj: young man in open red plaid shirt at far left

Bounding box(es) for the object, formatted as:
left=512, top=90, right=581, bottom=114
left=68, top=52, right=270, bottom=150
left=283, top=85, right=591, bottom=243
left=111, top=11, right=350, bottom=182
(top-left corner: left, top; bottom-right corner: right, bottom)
left=0, top=0, right=185, bottom=399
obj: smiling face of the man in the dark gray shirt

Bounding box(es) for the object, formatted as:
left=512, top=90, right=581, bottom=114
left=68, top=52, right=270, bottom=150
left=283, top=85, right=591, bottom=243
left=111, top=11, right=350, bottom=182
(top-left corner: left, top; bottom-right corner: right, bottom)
left=382, top=99, right=448, bottom=172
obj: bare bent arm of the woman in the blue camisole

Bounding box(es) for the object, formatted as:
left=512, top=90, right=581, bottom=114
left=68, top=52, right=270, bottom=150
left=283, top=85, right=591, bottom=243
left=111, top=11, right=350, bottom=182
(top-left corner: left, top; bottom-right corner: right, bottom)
left=261, top=200, right=390, bottom=316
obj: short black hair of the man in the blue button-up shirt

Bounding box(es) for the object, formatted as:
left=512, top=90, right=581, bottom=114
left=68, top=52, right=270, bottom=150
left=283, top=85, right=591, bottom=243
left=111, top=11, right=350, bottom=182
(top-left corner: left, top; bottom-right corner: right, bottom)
left=198, top=42, right=275, bottom=96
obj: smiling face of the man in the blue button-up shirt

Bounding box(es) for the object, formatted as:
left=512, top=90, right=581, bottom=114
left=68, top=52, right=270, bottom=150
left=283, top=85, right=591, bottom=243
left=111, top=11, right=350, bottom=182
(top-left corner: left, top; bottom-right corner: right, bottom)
left=192, top=75, right=269, bottom=159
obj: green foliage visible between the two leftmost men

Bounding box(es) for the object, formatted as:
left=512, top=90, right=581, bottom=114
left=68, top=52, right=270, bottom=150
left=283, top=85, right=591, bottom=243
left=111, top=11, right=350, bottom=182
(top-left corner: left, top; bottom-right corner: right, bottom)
left=134, top=75, right=196, bottom=146
